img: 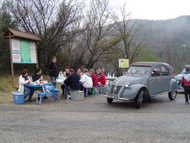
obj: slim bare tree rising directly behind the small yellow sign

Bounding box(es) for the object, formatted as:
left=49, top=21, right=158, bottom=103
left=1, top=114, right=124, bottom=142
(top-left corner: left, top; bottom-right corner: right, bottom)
left=114, top=5, right=142, bottom=63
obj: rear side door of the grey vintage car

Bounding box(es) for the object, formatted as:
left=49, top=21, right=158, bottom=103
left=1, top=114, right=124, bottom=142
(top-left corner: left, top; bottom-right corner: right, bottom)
left=160, top=65, right=172, bottom=92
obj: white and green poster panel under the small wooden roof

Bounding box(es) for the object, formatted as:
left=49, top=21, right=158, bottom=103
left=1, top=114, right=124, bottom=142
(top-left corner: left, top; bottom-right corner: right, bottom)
left=11, top=39, right=37, bottom=64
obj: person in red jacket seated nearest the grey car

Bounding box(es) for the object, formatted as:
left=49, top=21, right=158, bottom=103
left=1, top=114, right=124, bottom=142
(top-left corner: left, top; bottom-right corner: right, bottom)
left=96, top=68, right=106, bottom=94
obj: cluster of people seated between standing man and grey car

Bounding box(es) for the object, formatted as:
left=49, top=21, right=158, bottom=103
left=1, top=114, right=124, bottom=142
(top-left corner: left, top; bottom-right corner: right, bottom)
left=61, top=68, right=106, bottom=99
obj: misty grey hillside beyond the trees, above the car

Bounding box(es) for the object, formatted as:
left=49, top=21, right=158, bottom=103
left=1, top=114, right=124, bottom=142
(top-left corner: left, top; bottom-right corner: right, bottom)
left=132, top=16, right=190, bottom=68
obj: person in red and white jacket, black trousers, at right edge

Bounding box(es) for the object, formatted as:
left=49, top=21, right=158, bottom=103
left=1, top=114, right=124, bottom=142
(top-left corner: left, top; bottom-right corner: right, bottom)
left=181, top=68, right=190, bottom=104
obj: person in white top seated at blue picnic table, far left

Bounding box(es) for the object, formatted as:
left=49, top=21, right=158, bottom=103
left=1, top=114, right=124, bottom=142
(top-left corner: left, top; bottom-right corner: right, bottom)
left=18, top=69, right=34, bottom=101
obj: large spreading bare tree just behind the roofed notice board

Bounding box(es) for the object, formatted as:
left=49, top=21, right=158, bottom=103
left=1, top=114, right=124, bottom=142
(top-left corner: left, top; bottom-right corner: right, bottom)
left=5, top=0, right=81, bottom=66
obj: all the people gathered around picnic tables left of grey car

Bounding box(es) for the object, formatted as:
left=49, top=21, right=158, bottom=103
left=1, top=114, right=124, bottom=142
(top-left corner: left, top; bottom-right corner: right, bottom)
left=18, top=57, right=106, bottom=101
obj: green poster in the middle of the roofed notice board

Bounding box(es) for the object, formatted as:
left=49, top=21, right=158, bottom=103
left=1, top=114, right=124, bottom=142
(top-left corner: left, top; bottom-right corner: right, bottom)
left=20, top=40, right=31, bottom=63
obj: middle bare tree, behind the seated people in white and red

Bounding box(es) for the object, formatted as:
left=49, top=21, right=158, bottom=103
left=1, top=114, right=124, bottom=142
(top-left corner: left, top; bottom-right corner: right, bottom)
left=72, top=0, right=120, bottom=68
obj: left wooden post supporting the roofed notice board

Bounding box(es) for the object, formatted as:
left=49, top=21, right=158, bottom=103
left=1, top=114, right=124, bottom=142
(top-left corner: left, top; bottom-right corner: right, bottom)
left=9, top=33, right=15, bottom=87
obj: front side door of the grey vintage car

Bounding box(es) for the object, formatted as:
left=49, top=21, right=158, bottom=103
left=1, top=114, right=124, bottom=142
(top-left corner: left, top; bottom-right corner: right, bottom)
left=148, top=66, right=161, bottom=95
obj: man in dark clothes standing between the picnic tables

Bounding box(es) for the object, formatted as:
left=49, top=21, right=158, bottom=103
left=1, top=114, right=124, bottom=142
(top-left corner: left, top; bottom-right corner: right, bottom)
left=48, top=57, right=59, bottom=86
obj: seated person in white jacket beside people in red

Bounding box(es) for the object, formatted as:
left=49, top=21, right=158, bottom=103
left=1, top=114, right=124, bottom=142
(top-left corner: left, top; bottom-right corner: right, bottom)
left=80, top=69, right=93, bottom=97
